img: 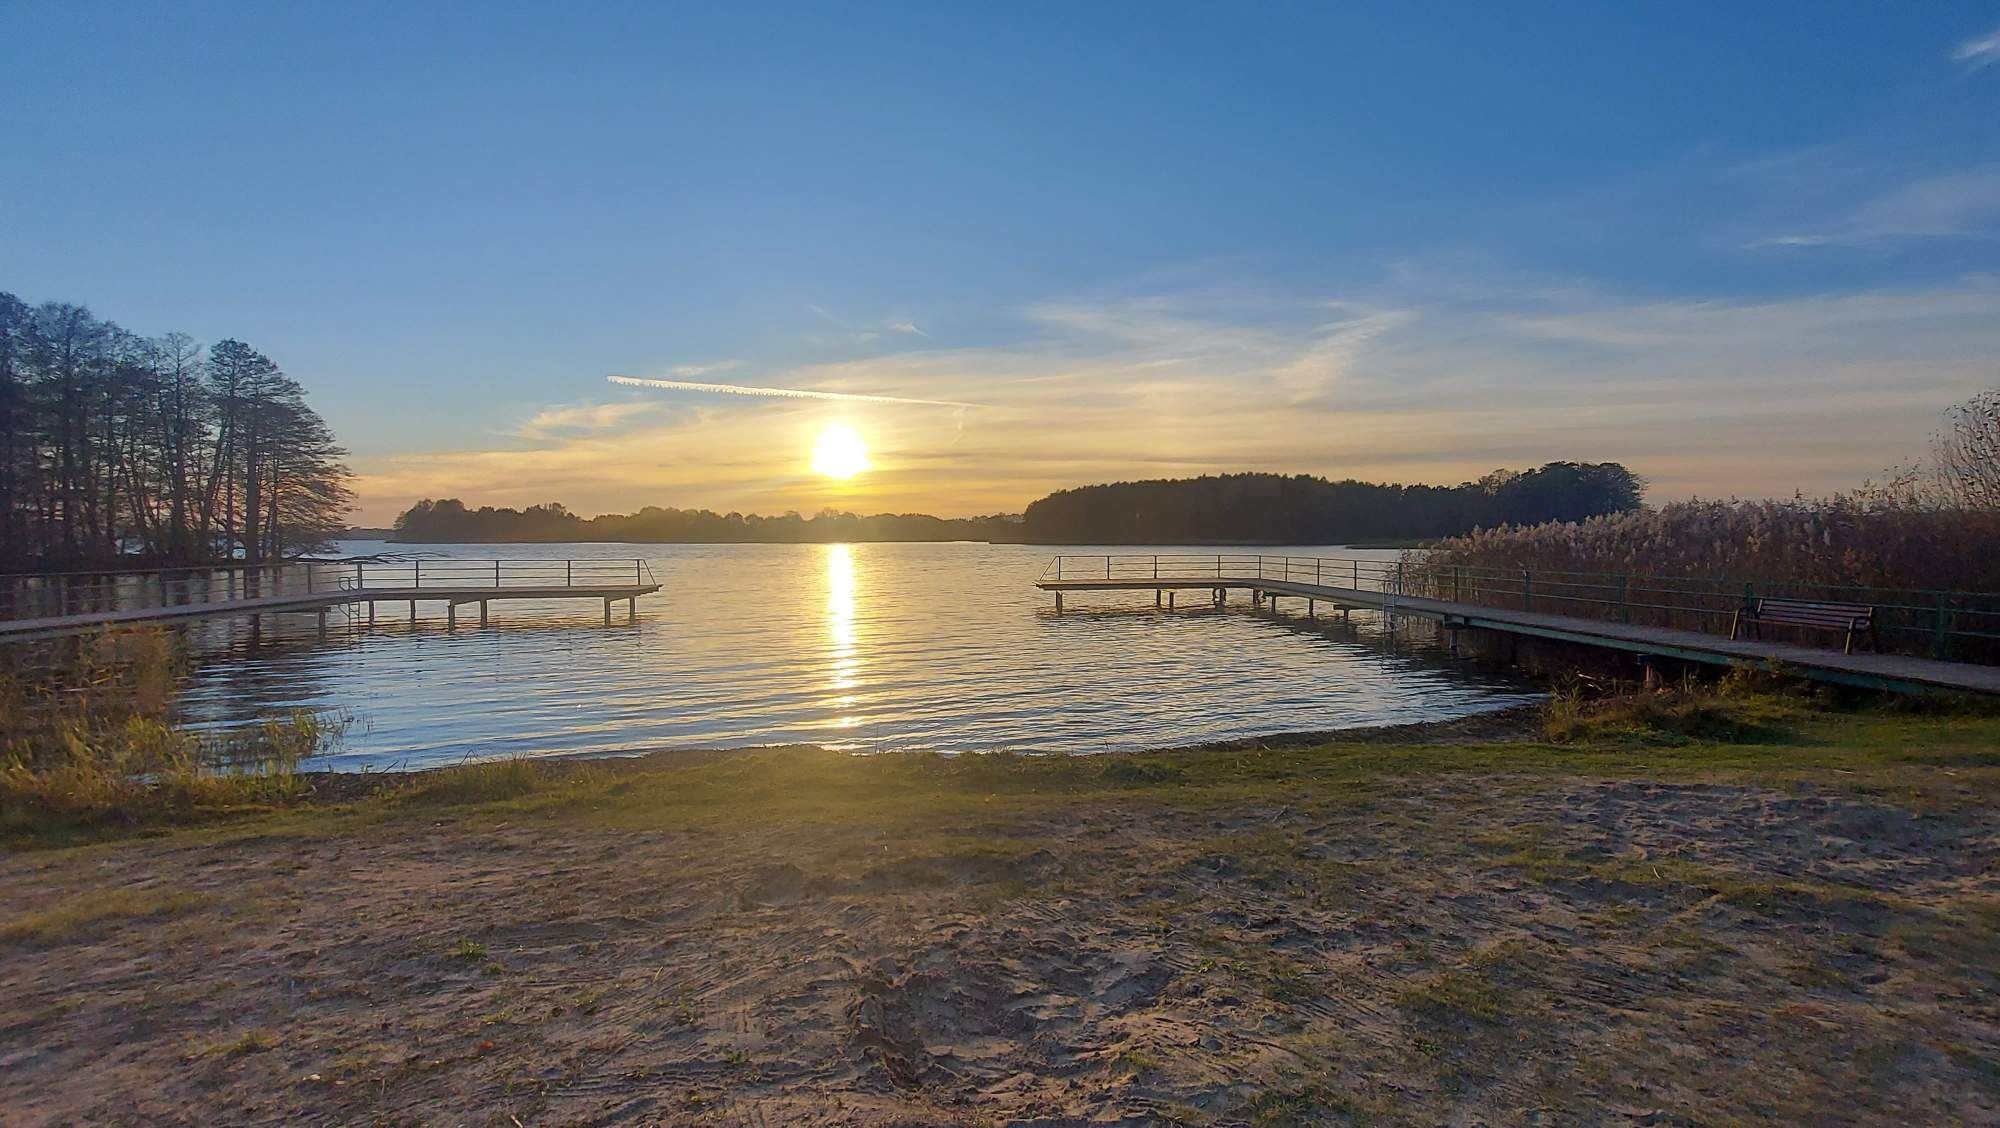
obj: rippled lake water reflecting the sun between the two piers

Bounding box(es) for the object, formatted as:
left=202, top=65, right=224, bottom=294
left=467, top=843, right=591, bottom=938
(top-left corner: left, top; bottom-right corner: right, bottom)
left=184, top=542, right=1536, bottom=770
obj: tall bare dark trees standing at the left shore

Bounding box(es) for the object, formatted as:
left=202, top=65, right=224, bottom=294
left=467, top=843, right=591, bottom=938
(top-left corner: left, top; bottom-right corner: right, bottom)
left=0, top=292, right=352, bottom=572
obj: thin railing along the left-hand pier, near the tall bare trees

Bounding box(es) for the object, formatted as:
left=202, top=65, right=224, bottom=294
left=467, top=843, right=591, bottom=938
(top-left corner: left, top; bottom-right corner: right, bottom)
left=0, top=558, right=656, bottom=620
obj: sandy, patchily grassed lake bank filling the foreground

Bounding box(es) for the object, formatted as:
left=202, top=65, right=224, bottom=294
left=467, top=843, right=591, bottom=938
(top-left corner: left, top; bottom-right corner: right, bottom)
left=0, top=694, right=2000, bottom=1124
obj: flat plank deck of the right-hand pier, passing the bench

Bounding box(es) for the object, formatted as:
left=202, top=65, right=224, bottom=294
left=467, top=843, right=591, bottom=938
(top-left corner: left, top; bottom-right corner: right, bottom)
left=1036, top=576, right=2000, bottom=694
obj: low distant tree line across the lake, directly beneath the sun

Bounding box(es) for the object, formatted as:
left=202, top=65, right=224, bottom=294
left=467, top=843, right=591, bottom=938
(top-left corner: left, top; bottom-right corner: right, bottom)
left=394, top=498, right=1020, bottom=544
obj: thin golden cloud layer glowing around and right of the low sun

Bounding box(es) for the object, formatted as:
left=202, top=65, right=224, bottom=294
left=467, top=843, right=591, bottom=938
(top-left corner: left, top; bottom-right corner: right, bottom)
left=362, top=274, right=2000, bottom=516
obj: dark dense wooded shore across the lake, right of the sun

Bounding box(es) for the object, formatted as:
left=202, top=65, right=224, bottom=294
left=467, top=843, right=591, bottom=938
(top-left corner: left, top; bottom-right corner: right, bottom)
left=1022, top=462, right=1646, bottom=544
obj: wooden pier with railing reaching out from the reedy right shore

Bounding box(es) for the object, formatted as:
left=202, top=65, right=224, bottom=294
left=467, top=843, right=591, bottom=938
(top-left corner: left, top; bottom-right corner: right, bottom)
left=1036, top=556, right=2000, bottom=694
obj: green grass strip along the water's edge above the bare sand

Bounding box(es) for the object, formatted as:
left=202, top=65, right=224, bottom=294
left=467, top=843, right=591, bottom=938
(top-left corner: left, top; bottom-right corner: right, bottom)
left=0, top=656, right=2000, bottom=852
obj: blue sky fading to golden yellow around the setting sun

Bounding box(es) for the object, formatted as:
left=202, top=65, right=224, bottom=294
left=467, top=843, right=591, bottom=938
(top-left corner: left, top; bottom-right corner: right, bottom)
left=0, top=0, right=2000, bottom=524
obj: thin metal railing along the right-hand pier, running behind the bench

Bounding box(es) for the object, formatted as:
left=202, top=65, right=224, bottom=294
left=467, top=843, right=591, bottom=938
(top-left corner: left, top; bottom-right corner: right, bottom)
left=1042, top=552, right=2000, bottom=664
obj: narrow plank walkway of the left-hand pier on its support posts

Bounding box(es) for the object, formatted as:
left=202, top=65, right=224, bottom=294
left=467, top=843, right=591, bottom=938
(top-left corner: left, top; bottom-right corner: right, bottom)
left=0, top=560, right=660, bottom=642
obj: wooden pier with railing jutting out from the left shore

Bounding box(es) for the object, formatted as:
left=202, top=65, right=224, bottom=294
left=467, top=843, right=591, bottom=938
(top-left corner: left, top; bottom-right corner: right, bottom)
left=0, top=560, right=660, bottom=642
